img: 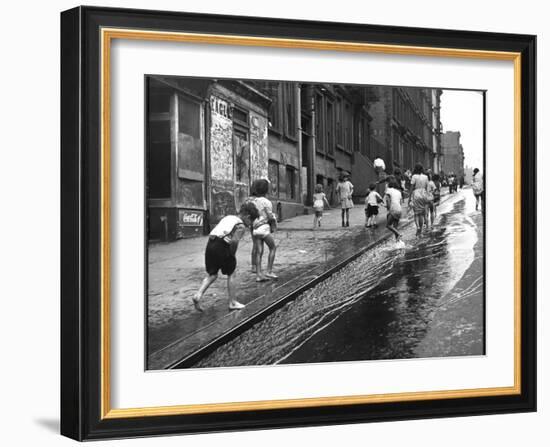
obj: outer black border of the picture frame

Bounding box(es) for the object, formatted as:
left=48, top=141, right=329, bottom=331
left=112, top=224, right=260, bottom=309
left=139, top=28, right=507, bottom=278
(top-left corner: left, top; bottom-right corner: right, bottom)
left=60, top=7, right=537, bottom=440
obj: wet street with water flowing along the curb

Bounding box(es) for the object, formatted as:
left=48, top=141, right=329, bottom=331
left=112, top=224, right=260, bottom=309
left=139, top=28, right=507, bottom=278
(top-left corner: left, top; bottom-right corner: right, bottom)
left=194, top=189, right=485, bottom=367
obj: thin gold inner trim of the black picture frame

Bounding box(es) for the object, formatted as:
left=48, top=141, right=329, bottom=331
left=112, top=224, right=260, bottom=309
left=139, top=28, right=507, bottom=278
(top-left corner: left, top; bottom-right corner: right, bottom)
left=100, top=28, right=521, bottom=419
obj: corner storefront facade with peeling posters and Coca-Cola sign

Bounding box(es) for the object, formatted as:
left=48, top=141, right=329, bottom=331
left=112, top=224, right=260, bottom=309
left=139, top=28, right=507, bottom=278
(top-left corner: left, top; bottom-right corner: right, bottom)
left=146, top=76, right=270, bottom=240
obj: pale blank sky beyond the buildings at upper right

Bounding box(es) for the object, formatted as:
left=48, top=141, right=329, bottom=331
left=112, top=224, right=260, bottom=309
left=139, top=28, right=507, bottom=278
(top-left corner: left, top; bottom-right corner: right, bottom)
left=441, top=90, right=483, bottom=171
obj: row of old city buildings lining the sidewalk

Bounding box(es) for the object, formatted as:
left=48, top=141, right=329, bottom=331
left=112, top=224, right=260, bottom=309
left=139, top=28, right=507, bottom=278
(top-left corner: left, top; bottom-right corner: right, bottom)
left=146, top=76, right=463, bottom=240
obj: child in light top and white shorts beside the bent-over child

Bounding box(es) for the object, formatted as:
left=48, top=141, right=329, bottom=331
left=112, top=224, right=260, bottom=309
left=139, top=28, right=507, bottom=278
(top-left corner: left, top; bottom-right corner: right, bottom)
left=252, top=179, right=278, bottom=282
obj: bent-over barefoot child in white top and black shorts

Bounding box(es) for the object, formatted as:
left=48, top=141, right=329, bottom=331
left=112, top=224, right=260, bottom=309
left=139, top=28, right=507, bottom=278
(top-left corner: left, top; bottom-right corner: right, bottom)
left=193, top=203, right=258, bottom=312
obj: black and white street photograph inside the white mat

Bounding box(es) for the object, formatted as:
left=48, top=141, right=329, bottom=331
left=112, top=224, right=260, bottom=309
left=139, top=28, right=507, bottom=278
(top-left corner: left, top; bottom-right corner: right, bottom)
left=145, top=75, right=486, bottom=370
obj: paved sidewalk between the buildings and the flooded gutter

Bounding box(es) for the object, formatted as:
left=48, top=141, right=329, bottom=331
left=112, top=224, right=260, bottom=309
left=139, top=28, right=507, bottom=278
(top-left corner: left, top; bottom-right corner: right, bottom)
left=148, top=191, right=450, bottom=369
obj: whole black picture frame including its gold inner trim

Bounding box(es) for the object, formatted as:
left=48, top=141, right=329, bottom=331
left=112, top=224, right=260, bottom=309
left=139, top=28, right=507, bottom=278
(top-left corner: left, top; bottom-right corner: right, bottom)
left=61, top=7, right=537, bottom=440
